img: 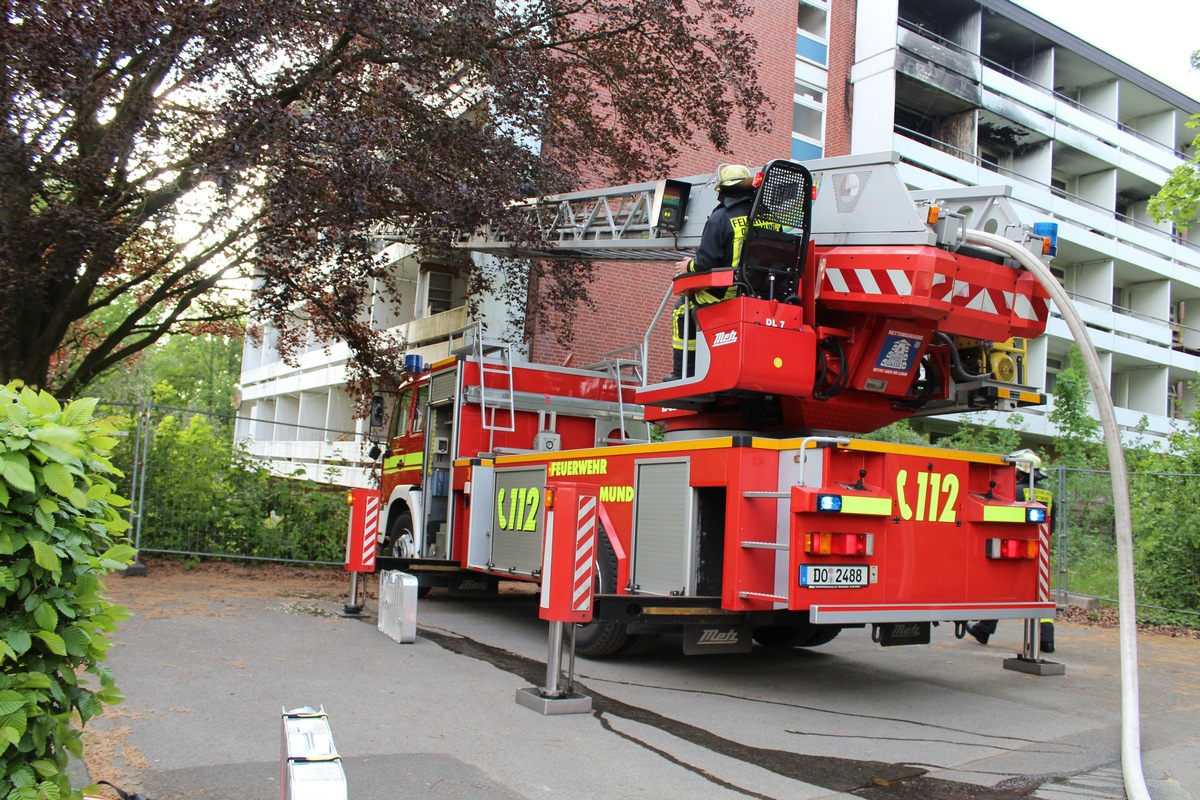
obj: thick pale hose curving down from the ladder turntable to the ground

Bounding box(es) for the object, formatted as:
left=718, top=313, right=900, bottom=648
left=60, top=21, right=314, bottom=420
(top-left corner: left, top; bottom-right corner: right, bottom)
left=964, top=230, right=1151, bottom=800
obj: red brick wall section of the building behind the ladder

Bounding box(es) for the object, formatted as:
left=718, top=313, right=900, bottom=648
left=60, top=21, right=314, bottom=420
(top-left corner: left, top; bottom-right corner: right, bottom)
left=532, top=0, right=801, bottom=380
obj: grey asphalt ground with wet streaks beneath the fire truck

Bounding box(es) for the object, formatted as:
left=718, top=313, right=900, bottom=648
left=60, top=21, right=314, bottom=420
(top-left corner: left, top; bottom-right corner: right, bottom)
left=86, top=570, right=1200, bottom=800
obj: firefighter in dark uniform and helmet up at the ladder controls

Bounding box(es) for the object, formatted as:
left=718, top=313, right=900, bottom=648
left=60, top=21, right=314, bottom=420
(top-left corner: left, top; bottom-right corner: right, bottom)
left=664, top=164, right=755, bottom=380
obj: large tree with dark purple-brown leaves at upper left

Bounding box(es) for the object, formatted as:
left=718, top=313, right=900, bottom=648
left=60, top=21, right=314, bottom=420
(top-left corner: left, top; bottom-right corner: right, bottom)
left=0, top=0, right=766, bottom=395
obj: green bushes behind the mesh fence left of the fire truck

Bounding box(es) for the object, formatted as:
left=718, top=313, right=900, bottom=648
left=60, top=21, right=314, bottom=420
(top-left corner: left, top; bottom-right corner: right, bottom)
left=129, top=414, right=348, bottom=561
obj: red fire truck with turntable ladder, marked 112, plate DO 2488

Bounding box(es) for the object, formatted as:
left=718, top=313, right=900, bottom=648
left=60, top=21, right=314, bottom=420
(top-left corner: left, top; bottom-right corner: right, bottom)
left=357, top=154, right=1054, bottom=657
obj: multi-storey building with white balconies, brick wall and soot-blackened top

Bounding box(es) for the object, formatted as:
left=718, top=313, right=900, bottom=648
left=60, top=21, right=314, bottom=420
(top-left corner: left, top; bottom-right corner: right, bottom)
left=239, top=0, right=1200, bottom=485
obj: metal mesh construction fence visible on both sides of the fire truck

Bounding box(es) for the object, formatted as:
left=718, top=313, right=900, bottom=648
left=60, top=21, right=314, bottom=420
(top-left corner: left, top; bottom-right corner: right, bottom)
left=100, top=403, right=1200, bottom=625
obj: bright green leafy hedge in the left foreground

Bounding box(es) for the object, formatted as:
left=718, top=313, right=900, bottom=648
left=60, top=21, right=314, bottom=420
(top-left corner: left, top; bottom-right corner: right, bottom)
left=0, top=384, right=134, bottom=800
